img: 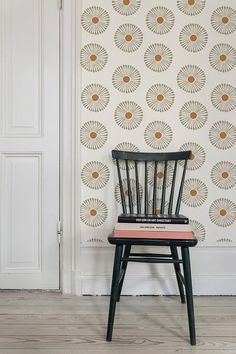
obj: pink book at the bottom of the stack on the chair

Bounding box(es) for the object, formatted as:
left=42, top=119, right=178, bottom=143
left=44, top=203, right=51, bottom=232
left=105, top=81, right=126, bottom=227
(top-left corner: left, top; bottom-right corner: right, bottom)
left=114, top=230, right=194, bottom=240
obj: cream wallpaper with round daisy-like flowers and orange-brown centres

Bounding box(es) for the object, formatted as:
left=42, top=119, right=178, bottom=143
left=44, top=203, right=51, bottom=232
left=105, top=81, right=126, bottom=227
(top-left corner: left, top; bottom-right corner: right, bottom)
left=78, top=0, right=236, bottom=247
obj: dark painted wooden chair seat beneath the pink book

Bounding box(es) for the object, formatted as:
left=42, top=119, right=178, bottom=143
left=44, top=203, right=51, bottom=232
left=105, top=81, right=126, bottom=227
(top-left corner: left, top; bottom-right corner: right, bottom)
left=108, top=230, right=198, bottom=247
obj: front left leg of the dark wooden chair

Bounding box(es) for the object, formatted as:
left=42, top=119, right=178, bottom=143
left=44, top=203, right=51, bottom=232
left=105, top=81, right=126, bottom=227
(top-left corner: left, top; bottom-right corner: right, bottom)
left=106, top=245, right=123, bottom=341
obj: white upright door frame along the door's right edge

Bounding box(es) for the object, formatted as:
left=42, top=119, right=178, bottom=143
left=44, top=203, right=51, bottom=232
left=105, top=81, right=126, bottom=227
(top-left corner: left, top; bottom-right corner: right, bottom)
left=59, top=0, right=82, bottom=295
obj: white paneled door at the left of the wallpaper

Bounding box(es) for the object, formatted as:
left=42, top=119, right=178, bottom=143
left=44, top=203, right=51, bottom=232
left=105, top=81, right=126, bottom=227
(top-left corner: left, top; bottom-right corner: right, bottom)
left=0, top=0, right=59, bottom=289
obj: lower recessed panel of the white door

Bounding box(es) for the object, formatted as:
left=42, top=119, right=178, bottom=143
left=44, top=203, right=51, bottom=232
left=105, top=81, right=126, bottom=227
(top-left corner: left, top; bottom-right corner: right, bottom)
left=2, top=154, right=42, bottom=273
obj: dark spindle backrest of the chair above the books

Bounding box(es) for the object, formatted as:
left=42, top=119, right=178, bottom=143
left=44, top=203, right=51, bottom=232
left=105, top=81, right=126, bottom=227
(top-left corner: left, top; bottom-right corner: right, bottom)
left=112, top=150, right=191, bottom=215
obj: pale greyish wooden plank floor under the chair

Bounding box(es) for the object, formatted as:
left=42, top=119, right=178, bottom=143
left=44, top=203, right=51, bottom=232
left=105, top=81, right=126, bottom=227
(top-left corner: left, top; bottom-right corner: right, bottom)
left=0, top=291, right=236, bottom=354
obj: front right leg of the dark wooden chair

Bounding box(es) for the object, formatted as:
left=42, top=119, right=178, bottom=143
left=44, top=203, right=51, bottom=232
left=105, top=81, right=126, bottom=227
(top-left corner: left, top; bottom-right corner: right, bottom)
left=181, top=247, right=196, bottom=345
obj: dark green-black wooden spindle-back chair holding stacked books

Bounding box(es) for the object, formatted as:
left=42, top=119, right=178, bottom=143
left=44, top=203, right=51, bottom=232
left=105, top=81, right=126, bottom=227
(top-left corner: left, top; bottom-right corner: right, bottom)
left=106, top=150, right=197, bottom=345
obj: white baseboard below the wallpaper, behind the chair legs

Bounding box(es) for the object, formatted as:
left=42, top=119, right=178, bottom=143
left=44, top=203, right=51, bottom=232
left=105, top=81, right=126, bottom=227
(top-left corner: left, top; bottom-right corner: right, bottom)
left=76, top=247, right=236, bottom=295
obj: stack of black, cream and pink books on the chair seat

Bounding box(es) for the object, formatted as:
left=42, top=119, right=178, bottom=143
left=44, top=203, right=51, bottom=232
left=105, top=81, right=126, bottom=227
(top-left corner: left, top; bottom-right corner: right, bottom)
left=114, top=214, right=193, bottom=240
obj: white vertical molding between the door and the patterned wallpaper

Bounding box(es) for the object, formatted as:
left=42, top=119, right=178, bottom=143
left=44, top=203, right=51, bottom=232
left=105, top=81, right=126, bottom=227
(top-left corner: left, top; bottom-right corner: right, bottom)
left=60, top=0, right=79, bottom=293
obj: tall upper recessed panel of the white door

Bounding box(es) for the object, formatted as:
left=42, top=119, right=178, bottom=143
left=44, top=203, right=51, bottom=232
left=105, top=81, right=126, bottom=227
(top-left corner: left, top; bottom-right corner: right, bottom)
left=1, top=0, right=43, bottom=136
